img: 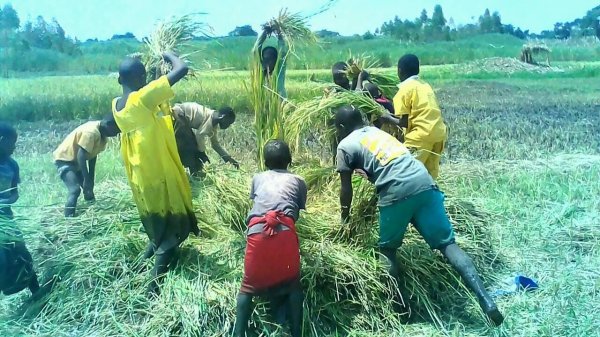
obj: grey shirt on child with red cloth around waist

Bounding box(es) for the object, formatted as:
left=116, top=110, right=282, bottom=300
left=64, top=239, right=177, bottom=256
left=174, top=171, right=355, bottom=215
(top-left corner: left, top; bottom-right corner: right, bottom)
left=248, top=170, right=307, bottom=221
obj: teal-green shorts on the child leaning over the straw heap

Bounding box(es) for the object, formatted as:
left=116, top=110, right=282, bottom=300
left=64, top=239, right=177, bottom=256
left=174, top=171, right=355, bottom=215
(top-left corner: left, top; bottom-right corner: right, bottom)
left=379, top=189, right=455, bottom=249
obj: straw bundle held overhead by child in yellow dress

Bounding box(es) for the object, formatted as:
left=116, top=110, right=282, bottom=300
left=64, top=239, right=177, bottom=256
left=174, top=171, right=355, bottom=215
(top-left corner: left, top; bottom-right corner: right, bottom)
left=141, top=13, right=212, bottom=80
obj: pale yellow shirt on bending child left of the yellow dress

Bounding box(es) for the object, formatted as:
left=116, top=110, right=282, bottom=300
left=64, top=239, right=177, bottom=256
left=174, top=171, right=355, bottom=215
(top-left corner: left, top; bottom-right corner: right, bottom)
left=52, top=121, right=107, bottom=162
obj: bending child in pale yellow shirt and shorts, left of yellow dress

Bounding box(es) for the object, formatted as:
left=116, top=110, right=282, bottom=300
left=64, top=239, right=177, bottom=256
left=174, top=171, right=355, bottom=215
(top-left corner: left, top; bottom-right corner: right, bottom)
left=53, top=116, right=119, bottom=217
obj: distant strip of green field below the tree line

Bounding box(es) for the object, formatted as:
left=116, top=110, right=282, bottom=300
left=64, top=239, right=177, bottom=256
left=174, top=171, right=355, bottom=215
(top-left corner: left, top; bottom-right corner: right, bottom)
left=3, top=34, right=600, bottom=77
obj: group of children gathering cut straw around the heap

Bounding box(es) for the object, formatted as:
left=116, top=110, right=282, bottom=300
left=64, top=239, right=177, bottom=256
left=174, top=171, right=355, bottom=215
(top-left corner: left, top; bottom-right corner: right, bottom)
left=0, top=23, right=503, bottom=336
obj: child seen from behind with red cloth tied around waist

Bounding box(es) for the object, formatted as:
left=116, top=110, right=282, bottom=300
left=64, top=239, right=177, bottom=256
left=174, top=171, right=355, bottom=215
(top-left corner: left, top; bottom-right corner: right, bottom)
left=234, top=140, right=307, bottom=337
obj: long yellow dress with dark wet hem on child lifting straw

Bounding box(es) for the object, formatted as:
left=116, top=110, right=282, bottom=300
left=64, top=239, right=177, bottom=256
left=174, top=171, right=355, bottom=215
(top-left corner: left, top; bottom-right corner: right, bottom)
left=112, top=76, right=199, bottom=254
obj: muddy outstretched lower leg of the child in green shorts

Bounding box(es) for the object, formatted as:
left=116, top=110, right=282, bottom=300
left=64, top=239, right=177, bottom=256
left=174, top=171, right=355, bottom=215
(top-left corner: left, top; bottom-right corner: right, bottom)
left=441, top=244, right=504, bottom=326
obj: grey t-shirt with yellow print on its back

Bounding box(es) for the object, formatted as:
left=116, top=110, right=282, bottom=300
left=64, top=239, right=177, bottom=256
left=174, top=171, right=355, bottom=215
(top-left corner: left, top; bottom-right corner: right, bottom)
left=337, top=126, right=435, bottom=207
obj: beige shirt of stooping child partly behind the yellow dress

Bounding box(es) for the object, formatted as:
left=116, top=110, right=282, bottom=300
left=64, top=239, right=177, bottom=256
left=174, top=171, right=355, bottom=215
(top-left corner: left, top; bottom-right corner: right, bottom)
left=173, top=102, right=219, bottom=152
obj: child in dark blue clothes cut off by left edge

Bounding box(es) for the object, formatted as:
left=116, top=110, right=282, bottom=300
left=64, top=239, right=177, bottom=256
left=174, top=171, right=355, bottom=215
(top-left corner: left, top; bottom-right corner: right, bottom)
left=0, top=122, right=40, bottom=295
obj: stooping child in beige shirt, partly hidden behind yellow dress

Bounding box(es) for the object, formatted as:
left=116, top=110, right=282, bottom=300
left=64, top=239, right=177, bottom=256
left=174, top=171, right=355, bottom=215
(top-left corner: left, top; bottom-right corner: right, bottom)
left=173, top=102, right=240, bottom=174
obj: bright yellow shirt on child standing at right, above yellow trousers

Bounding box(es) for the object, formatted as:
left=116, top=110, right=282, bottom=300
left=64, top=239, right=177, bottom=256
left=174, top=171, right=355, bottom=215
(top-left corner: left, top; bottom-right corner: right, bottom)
left=394, top=76, right=447, bottom=147
